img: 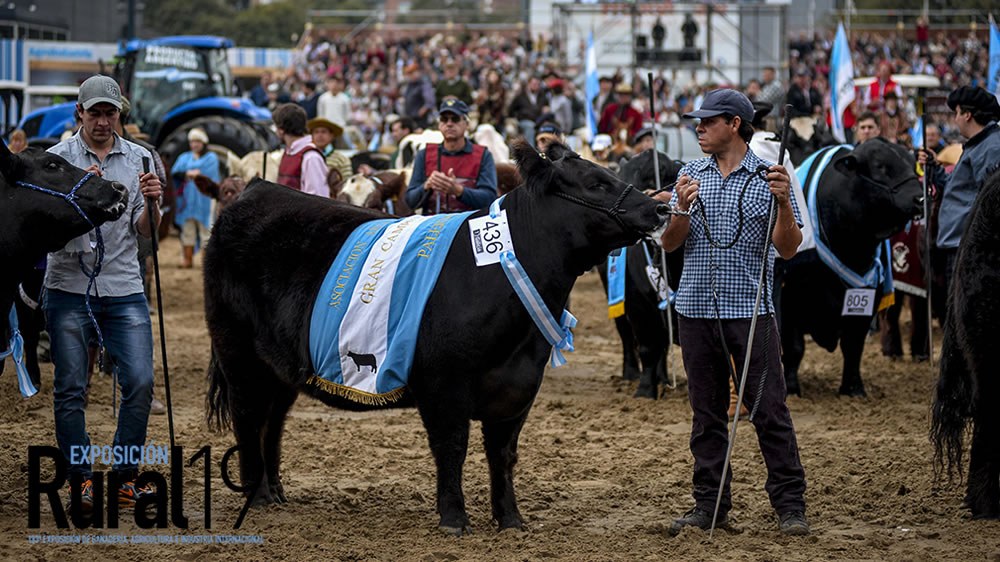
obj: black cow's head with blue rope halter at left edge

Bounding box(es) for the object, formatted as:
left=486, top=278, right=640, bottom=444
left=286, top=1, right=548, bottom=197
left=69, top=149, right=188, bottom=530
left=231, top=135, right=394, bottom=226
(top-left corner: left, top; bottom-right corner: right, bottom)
left=0, top=142, right=128, bottom=263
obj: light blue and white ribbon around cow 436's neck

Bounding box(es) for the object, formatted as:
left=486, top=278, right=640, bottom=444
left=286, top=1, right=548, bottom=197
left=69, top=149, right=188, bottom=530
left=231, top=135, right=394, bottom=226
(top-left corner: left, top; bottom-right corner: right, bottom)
left=490, top=196, right=576, bottom=367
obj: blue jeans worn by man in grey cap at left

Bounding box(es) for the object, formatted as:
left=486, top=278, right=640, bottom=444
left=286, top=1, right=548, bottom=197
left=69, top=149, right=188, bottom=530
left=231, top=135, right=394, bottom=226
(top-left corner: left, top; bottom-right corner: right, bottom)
left=42, top=290, right=153, bottom=479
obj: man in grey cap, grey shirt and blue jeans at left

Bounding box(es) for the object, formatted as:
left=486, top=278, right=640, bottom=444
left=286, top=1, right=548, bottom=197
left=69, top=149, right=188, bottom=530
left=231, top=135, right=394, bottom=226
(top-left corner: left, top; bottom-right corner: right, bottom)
left=43, top=75, right=160, bottom=513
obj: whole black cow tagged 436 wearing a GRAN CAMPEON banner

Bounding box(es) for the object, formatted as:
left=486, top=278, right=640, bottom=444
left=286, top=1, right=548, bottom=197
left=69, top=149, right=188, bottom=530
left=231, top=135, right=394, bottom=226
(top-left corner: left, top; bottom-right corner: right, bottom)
left=204, top=141, right=668, bottom=535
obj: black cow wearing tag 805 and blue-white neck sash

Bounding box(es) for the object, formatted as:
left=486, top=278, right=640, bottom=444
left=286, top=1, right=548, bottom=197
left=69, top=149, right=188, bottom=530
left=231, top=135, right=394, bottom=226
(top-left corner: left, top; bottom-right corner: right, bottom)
left=780, top=137, right=923, bottom=396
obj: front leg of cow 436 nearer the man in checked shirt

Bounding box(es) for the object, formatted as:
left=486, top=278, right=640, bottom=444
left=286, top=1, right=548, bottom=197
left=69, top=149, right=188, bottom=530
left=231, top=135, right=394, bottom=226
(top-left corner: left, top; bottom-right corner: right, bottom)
left=483, top=412, right=528, bottom=530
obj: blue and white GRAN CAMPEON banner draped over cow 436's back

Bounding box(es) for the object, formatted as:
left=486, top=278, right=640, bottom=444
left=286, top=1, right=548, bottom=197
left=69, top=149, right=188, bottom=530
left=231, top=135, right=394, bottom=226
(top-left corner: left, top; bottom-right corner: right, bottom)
left=308, top=212, right=472, bottom=405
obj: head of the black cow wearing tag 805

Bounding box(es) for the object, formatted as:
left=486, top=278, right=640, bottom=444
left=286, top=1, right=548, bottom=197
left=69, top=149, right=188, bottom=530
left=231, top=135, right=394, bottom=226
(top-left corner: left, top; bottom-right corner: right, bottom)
left=834, top=137, right=923, bottom=240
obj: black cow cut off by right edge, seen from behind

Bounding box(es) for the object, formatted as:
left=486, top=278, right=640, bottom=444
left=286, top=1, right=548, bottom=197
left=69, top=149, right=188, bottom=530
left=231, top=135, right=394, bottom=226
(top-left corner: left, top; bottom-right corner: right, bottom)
left=930, top=168, right=1000, bottom=519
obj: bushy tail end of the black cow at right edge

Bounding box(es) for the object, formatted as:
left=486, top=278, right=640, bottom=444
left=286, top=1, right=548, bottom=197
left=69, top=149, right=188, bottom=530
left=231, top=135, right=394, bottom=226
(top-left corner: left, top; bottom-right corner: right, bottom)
left=930, top=312, right=975, bottom=481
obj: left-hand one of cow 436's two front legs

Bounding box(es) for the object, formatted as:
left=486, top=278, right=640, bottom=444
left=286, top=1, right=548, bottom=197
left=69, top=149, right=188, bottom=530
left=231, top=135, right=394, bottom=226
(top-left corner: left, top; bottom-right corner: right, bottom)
left=421, top=414, right=471, bottom=536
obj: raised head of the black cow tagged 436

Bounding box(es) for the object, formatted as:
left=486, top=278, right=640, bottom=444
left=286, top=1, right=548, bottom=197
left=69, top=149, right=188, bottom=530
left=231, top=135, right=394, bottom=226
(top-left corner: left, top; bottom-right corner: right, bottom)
left=513, top=141, right=668, bottom=256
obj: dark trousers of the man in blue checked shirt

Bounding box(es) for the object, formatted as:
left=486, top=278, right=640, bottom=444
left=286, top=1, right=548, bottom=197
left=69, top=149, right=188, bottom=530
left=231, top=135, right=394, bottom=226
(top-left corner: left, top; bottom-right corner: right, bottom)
left=678, top=315, right=806, bottom=515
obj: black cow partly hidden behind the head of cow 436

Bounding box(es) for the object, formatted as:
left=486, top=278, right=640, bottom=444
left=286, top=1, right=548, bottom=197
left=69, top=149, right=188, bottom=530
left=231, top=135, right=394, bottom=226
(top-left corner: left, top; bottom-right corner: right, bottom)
left=598, top=149, right=684, bottom=399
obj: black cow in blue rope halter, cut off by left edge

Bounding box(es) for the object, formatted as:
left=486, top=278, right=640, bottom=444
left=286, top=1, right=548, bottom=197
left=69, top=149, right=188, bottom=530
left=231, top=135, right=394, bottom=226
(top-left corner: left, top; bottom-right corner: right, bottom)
left=0, top=142, right=128, bottom=396
